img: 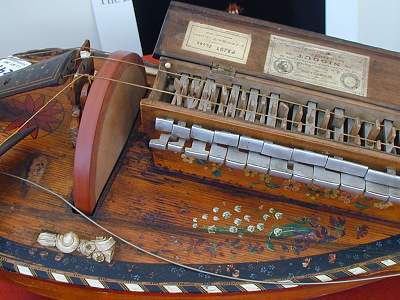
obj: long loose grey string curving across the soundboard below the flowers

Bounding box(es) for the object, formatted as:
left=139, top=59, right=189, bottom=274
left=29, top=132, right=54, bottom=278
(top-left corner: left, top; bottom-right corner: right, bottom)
left=0, top=171, right=400, bottom=286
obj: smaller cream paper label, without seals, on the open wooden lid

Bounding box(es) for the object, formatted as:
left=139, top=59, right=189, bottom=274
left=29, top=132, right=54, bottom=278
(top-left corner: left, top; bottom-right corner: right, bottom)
left=182, top=21, right=251, bottom=64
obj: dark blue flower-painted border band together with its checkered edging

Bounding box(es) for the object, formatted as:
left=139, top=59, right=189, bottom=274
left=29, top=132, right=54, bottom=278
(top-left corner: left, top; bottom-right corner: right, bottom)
left=0, top=236, right=400, bottom=293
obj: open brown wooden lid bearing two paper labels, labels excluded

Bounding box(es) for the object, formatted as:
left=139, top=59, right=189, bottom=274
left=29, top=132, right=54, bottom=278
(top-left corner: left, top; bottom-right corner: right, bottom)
left=155, top=2, right=400, bottom=110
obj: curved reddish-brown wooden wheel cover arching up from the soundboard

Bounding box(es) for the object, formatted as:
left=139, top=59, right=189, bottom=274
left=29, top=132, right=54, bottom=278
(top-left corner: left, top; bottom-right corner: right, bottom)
left=74, top=52, right=146, bottom=214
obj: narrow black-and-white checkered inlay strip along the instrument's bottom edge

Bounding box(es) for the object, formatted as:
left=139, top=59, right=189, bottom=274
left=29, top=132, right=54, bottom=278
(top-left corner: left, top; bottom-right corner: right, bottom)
left=0, top=256, right=400, bottom=294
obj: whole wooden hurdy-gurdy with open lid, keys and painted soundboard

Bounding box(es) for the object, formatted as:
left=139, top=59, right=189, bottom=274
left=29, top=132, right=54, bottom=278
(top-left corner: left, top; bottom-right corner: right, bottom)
left=0, top=2, right=400, bottom=299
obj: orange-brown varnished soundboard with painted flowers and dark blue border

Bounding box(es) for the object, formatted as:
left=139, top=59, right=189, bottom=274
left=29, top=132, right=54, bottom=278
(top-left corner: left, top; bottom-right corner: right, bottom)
left=0, top=81, right=400, bottom=299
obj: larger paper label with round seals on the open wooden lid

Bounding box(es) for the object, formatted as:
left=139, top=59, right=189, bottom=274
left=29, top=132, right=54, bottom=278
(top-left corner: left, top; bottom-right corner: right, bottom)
left=264, top=35, right=369, bottom=97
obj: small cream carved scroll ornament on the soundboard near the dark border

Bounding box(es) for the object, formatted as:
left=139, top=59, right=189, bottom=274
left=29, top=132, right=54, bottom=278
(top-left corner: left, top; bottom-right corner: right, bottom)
left=37, top=232, right=116, bottom=263
